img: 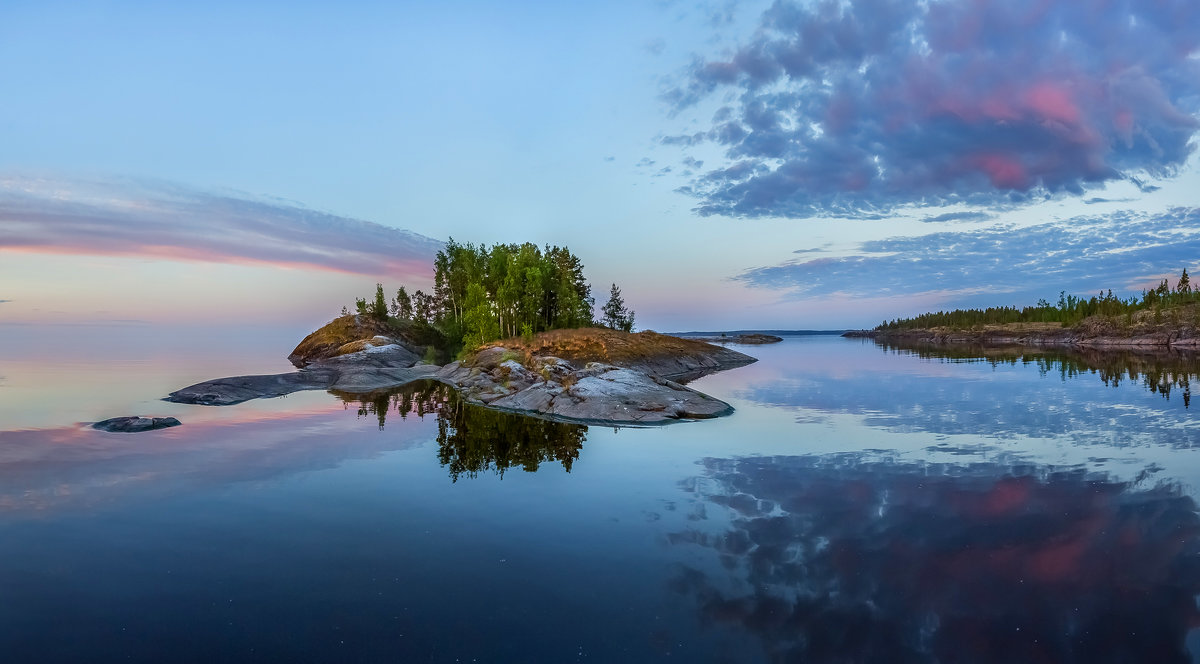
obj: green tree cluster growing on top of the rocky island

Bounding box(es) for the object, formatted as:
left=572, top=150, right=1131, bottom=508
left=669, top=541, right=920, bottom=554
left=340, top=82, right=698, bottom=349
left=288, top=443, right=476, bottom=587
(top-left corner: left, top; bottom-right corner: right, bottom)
left=342, top=238, right=634, bottom=354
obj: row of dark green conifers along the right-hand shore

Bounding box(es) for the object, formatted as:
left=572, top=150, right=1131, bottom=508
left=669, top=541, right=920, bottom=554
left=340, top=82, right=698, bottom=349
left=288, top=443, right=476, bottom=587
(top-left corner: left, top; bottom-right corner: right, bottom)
left=875, top=269, right=1200, bottom=331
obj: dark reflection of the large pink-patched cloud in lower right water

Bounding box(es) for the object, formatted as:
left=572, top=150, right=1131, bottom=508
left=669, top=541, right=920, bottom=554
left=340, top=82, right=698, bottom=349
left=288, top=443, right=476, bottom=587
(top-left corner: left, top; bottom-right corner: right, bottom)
left=671, top=455, right=1200, bottom=663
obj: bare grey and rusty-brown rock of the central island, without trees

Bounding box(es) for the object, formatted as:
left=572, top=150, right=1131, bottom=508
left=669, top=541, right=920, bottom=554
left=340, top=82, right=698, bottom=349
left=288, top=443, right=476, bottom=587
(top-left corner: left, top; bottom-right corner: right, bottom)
left=167, top=315, right=755, bottom=425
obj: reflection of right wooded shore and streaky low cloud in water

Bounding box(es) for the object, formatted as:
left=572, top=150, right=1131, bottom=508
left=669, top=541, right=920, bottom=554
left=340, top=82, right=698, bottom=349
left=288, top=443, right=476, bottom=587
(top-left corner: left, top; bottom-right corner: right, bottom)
left=730, top=340, right=1200, bottom=441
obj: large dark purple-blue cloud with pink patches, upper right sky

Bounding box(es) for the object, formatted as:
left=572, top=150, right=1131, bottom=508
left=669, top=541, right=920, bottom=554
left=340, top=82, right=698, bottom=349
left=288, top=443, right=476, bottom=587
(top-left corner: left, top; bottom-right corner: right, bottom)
left=661, top=0, right=1200, bottom=217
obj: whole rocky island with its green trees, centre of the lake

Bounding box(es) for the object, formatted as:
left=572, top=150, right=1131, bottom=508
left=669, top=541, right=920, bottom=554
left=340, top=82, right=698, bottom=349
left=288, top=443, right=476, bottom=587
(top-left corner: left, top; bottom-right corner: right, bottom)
left=167, top=239, right=755, bottom=425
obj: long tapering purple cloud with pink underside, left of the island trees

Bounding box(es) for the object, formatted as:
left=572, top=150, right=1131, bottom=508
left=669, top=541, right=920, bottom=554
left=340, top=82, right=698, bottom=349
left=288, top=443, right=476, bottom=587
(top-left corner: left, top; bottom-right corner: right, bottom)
left=0, top=178, right=442, bottom=276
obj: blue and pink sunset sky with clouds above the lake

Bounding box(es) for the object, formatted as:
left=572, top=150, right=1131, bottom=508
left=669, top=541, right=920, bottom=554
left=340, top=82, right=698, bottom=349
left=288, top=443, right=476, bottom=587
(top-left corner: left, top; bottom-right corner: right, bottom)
left=0, top=0, right=1200, bottom=331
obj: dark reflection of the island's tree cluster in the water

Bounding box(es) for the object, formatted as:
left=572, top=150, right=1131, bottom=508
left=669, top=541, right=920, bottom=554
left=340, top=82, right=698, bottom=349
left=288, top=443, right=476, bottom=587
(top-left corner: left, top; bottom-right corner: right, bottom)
left=334, top=381, right=588, bottom=481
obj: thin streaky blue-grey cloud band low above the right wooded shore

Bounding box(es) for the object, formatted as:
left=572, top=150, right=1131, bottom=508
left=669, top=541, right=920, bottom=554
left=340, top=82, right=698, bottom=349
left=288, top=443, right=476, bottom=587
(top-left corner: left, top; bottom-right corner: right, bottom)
left=734, top=208, right=1200, bottom=304
